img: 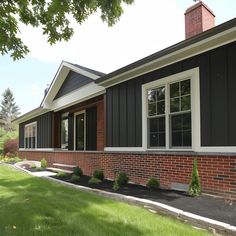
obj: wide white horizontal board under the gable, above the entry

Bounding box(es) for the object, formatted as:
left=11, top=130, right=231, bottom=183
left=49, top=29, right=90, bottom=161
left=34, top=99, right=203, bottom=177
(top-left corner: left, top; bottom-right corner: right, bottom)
left=51, top=82, right=105, bottom=111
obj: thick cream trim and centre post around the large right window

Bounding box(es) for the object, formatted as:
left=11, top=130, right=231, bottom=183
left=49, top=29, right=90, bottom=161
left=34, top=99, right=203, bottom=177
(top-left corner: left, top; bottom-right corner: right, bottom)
left=142, top=67, right=201, bottom=151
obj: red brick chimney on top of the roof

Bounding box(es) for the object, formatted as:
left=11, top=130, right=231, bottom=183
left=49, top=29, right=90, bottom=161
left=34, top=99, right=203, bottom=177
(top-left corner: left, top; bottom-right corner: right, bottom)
left=184, top=1, right=215, bottom=39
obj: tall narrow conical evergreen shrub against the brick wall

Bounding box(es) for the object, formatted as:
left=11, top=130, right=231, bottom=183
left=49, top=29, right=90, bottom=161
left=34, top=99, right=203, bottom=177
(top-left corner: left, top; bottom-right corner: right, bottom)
left=188, top=159, right=201, bottom=196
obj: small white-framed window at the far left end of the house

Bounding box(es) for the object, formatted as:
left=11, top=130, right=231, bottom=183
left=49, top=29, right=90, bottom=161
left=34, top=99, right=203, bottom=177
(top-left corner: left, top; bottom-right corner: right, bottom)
left=24, top=122, right=37, bottom=148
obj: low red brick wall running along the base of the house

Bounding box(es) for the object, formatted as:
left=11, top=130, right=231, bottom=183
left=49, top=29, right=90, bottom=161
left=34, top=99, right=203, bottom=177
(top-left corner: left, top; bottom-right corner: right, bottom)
left=20, top=151, right=236, bottom=200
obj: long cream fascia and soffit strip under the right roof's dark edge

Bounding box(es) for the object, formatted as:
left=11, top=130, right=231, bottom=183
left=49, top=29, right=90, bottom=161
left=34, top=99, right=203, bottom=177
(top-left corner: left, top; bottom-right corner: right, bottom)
left=99, top=27, right=236, bottom=88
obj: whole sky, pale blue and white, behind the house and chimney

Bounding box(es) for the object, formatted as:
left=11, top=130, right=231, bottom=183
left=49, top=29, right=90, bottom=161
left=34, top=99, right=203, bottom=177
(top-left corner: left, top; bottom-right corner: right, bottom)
left=0, top=0, right=236, bottom=113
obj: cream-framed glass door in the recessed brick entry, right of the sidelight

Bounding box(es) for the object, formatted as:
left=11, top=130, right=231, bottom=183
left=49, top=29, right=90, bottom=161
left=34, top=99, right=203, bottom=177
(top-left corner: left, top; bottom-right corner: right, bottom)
left=75, top=113, right=85, bottom=150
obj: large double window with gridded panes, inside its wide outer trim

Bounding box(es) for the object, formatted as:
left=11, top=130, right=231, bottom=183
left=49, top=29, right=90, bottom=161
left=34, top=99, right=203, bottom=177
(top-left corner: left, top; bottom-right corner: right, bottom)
left=147, top=78, right=192, bottom=148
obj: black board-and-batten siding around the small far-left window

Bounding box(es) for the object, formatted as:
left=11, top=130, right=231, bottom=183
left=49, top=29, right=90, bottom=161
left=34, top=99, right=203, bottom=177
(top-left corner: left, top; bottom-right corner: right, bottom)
left=19, top=112, right=53, bottom=148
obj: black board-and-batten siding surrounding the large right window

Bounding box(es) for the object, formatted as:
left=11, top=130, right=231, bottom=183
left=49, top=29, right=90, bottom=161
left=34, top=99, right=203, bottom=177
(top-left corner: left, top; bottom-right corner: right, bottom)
left=106, top=42, right=236, bottom=147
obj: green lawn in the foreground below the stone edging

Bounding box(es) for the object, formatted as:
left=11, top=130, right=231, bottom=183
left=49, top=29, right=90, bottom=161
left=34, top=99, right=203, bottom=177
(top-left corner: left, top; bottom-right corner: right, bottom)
left=0, top=166, right=209, bottom=236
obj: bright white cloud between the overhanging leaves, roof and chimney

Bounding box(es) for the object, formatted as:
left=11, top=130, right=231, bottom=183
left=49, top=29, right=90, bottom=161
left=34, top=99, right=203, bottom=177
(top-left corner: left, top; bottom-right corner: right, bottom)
left=18, top=0, right=184, bottom=72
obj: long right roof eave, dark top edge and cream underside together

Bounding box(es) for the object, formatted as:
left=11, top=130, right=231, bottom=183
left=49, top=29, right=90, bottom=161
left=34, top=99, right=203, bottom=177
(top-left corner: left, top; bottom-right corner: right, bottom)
left=96, top=18, right=236, bottom=87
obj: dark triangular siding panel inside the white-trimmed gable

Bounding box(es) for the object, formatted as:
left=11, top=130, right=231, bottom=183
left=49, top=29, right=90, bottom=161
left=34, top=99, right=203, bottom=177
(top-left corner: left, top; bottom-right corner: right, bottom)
left=54, top=70, right=93, bottom=100
